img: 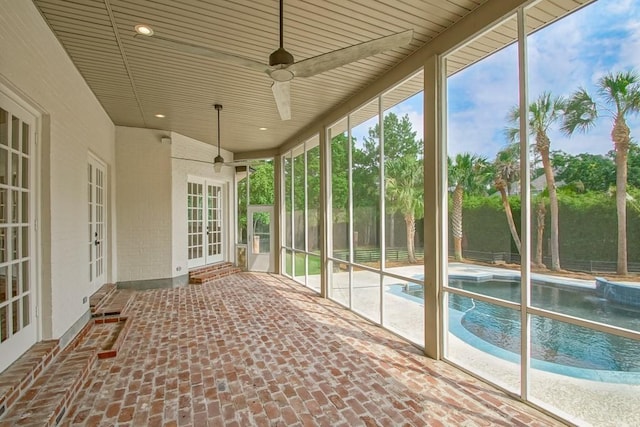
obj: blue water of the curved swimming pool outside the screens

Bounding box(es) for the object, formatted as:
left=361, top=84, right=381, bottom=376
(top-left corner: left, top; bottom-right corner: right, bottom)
left=403, top=280, right=640, bottom=372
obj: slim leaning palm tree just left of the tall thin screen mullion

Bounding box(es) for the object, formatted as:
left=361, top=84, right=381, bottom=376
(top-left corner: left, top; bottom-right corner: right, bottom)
left=493, top=144, right=520, bottom=253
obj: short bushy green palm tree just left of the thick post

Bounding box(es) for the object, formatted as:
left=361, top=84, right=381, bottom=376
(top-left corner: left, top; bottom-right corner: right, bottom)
left=385, top=156, right=424, bottom=263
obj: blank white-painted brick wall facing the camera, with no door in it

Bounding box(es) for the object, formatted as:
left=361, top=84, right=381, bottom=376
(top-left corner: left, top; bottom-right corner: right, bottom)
left=116, top=126, right=172, bottom=282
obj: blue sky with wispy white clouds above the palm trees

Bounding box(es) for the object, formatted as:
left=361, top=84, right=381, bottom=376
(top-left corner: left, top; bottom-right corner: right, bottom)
left=378, top=0, right=640, bottom=160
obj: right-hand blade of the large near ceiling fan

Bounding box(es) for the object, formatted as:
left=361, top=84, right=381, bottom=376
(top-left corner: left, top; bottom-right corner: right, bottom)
left=288, top=30, right=413, bottom=77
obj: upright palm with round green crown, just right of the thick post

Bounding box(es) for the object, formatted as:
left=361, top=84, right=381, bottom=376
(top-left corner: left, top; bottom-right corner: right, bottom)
left=448, top=153, right=488, bottom=261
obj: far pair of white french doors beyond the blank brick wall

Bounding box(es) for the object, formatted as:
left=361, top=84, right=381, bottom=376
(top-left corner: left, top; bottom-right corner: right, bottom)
left=187, top=177, right=224, bottom=268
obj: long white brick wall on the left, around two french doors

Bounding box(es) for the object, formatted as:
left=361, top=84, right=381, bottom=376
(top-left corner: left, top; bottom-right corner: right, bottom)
left=0, top=0, right=117, bottom=338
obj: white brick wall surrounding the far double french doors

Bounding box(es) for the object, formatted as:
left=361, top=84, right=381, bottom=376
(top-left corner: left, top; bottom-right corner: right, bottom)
left=171, top=132, right=236, bottom=276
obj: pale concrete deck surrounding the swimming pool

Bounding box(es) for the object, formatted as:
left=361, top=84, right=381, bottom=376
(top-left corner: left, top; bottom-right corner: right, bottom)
left=320, top=263, right=640, bottom=426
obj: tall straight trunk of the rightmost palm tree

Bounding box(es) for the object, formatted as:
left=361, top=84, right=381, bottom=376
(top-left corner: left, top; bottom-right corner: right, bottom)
left=611, top=116, right=630, bottom=275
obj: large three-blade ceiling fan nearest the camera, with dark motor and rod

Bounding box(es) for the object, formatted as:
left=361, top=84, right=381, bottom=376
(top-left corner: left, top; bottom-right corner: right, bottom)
left=136, top=0, right=413, bottom=120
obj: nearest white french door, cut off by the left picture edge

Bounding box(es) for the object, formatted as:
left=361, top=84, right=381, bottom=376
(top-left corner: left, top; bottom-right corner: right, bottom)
left=0, top=88, right=38, bottom=372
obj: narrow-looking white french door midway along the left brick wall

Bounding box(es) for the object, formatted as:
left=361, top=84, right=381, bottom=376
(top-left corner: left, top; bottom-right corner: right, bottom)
left=87, top=155, right=107, bottom=291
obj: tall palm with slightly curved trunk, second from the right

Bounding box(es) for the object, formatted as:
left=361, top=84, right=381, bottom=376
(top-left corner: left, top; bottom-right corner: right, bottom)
left=507, top=92, right=565, bottom=271
